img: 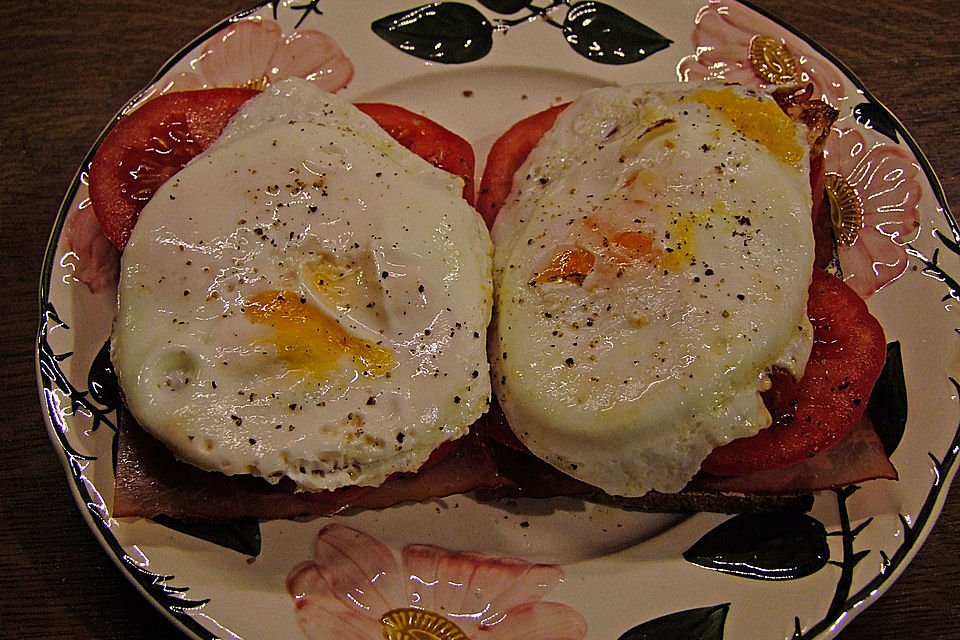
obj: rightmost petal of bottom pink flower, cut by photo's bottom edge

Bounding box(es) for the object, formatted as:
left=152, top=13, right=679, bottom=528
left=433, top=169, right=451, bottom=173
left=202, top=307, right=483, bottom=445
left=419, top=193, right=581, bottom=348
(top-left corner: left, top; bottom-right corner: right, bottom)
left=474, top=602, right=587, bottom=640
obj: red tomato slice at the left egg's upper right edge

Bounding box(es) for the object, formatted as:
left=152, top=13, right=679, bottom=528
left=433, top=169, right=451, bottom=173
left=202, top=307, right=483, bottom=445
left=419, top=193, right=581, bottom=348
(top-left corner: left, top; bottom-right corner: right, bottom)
left=355, top=102, right=475, bottom=206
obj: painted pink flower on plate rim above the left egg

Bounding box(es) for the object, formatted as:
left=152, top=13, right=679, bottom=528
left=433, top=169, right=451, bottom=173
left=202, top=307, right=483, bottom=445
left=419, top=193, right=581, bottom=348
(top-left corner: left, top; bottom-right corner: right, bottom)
left=161, top=19, right=353, bottom=93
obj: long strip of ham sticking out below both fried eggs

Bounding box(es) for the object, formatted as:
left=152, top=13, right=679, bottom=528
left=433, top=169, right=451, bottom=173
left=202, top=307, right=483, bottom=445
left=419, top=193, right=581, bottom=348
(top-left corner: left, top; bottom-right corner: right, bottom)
left=113, top=404, right=897, bottom=521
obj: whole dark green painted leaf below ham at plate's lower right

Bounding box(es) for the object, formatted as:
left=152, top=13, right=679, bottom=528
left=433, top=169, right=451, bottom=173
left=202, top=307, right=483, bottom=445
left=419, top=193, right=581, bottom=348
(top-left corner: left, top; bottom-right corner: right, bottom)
left=683, top=512, right=830, bottom=580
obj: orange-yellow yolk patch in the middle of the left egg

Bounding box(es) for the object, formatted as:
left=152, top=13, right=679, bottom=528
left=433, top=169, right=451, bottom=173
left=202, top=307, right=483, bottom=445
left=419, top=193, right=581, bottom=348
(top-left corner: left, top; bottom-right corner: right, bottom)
left=245, top=291, right=393, bottom=378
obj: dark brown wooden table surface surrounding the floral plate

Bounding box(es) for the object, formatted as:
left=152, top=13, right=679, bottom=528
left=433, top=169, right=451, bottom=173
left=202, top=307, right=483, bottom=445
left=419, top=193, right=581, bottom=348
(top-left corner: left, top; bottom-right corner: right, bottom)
left=0, top=0, right=960, bottom=640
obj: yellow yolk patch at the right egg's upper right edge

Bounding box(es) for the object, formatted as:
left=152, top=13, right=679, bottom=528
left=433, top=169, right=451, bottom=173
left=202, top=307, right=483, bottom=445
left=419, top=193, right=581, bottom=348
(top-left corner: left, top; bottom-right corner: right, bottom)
left=691, top=88, right=805, bottom=166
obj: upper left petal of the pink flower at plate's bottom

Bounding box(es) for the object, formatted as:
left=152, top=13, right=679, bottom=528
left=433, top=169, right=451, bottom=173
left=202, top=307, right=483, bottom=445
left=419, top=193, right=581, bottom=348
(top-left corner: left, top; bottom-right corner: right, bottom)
left=313, top=524, right=406, bottom=619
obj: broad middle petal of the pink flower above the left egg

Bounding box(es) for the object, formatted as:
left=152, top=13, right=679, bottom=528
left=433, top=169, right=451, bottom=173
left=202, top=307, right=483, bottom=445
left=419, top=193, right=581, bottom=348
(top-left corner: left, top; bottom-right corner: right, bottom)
left=190, top=20, right=282, bottom=87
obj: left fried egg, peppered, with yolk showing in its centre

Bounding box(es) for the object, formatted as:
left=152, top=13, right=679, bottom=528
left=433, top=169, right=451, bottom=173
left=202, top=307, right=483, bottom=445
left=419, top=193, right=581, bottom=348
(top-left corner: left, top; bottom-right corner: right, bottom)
left=111, top=80, right=492, bottom=491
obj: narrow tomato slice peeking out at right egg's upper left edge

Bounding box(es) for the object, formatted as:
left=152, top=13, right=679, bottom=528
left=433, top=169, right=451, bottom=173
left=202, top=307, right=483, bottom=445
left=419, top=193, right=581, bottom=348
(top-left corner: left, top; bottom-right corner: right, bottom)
left=477, top=102, right=570, bottom=227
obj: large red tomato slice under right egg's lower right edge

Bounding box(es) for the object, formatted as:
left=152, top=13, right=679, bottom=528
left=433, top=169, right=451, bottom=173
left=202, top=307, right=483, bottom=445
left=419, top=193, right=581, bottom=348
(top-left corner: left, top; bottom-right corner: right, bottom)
left=701, top=269, right=886, bottom=476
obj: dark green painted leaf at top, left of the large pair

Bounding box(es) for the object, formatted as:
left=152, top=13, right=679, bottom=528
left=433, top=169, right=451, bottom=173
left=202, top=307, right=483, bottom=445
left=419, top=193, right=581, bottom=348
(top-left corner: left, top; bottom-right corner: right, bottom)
left=370, top=2, right=493, bottom=64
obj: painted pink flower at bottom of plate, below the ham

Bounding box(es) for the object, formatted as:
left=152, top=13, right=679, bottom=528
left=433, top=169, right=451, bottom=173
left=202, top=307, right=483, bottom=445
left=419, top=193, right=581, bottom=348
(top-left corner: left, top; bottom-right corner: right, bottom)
left=287, top=524, right=587, bottom=640
